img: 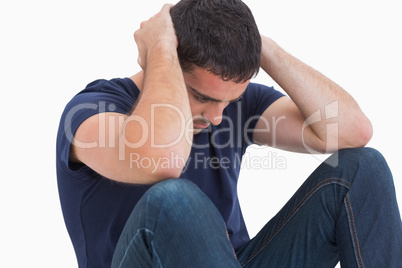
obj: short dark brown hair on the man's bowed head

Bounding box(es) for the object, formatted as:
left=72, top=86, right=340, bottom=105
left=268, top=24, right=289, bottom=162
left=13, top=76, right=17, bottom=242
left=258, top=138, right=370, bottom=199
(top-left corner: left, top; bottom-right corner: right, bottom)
left=171, top=0, right=261, bottom=82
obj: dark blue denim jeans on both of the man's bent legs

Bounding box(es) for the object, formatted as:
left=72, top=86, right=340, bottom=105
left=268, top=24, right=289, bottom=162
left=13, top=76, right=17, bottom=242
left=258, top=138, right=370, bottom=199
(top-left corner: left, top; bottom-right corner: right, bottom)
left=112, top=148, right=402, bottom=268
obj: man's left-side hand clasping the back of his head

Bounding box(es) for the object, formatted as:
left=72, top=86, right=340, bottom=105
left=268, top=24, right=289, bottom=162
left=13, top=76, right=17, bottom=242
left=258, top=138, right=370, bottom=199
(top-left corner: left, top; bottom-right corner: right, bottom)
left=134, top=4, right=178, bottom=70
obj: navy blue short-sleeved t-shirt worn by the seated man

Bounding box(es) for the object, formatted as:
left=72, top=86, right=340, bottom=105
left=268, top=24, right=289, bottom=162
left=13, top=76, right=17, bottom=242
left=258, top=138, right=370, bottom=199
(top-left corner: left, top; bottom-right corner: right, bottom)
left=56, top=78, right=283, bottom=268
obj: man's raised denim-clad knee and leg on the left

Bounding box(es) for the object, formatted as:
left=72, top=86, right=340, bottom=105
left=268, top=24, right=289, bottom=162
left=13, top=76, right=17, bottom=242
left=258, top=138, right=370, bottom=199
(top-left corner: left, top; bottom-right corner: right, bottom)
left=112, top=179, right=240, bottom=268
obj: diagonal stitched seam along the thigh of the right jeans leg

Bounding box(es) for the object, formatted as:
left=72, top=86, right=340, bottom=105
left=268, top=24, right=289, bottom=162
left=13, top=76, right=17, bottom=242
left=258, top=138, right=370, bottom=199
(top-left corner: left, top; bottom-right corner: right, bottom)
left=241, top=178, right=351, bottom=266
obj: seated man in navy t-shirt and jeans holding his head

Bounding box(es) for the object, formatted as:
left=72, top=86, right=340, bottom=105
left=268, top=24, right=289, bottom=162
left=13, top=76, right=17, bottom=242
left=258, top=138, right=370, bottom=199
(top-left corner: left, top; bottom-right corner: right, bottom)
left=57, top=0, right=402, bottom=267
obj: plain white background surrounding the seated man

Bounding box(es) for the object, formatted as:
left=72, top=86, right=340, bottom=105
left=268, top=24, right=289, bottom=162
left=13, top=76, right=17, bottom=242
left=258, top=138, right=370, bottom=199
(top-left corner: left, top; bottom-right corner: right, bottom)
left=0, top=0, right=402, bottom=267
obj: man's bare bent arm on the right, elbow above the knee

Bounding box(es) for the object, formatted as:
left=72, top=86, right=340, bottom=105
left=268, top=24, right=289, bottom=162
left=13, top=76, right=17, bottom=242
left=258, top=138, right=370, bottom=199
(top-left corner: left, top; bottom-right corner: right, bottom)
left=254, top=37, right=372, bottom=153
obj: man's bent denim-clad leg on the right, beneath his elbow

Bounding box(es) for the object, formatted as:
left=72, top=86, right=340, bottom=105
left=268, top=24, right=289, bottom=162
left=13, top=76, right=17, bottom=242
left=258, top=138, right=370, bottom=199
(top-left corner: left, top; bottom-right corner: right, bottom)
left=237, top=148, right=402, bottom=268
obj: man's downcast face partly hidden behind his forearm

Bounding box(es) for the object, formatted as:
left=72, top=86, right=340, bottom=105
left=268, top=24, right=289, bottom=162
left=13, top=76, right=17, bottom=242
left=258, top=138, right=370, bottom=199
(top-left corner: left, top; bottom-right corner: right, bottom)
left=183, top=67, right=250, bottom=134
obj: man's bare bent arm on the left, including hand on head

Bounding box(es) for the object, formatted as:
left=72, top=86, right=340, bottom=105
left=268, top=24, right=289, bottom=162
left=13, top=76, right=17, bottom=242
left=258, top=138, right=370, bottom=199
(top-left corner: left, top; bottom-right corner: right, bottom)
left=71, top=5, right=192, bottom=184
